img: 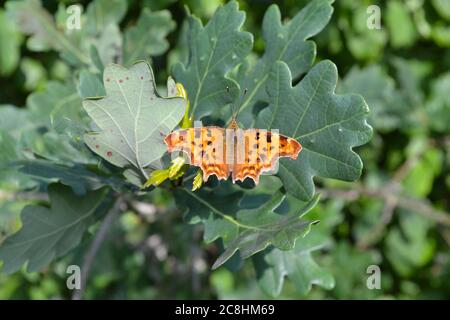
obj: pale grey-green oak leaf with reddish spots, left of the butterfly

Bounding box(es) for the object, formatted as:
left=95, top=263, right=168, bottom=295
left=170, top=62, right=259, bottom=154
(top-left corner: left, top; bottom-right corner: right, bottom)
left=83, top=62, right=186, bottom=178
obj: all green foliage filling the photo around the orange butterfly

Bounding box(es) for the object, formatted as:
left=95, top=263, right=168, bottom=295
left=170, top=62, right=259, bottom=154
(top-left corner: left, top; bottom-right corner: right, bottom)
left=0, top=0, right=450, bottom=299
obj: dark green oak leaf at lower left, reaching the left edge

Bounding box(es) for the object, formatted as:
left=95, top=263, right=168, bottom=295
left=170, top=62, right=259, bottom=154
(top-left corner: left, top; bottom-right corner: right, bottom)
left=0, top=185, right=105, bottom=273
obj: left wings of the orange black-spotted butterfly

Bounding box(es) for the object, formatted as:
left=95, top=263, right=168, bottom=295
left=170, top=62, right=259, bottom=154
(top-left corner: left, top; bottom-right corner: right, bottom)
left=164, top=127, right=230, bottom=181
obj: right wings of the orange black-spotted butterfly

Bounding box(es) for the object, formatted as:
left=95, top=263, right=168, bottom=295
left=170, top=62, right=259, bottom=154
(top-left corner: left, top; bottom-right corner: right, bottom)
left=232, top=129, right=302, bottom=184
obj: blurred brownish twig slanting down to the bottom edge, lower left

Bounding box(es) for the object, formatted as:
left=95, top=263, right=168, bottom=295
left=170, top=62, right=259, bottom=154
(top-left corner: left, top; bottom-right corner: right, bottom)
left=72, top=197, right=124, bottom=300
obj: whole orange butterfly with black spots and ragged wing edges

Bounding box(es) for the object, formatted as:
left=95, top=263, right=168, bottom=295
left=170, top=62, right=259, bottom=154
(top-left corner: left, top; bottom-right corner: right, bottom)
left=164, top=125, right=302, bottom=184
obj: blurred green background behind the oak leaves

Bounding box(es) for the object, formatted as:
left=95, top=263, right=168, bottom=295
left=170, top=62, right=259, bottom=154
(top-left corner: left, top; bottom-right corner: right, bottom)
left=0, top=0, right=450, bottom=299
